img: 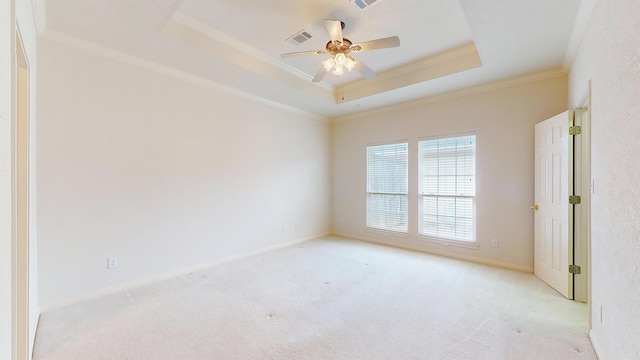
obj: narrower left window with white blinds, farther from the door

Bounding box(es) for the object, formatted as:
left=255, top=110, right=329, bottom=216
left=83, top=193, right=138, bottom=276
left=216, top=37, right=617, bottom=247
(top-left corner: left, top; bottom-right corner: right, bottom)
left=367, top=142, right=409, bottom=233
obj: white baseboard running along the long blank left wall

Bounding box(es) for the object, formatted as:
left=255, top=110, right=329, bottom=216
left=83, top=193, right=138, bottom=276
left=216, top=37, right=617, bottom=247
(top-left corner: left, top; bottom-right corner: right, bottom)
left=40, top=232, right=330, bottom=313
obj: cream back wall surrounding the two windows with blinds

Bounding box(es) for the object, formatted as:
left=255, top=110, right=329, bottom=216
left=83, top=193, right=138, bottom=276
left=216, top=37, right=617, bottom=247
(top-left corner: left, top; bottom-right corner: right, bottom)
left=332, top=76, right=567, bottom=272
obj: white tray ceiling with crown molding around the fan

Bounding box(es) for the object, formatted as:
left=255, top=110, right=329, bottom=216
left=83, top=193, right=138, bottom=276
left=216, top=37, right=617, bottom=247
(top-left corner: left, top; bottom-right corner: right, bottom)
left=39, top=0, right=581, bottom=117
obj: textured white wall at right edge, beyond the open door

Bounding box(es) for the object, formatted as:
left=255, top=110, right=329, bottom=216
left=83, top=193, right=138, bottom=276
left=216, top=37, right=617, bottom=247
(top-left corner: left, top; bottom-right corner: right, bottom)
left=569, top=0, right=640, bottom=359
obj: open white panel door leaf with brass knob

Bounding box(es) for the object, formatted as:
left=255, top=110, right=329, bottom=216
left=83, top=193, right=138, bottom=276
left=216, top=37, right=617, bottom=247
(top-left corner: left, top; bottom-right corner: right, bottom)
left=532, top=112, right=573, bottom=298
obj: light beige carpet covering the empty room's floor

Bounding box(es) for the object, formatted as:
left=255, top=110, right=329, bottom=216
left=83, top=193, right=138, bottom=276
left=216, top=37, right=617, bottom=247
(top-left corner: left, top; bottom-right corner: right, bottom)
left=34, top=237, right=596, bottom=360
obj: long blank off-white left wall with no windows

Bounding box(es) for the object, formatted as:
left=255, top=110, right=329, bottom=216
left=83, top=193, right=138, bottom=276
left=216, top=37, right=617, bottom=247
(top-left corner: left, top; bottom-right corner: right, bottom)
left=38, top=39, right=330, bottom=306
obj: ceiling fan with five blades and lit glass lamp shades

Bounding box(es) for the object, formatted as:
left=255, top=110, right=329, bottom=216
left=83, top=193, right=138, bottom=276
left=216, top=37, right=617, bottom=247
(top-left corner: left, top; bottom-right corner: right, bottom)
left=281, top=20, right=400, bottom=82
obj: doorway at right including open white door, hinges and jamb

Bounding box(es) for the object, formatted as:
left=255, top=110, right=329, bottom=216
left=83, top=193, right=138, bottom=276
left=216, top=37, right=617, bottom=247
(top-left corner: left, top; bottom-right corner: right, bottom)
left=531, top=95, right=591, bottom=303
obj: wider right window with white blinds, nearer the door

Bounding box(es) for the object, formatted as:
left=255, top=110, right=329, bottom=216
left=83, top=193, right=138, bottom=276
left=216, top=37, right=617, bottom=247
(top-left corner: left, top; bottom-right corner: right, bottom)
left=418, top=135, right=476, bottom=243
